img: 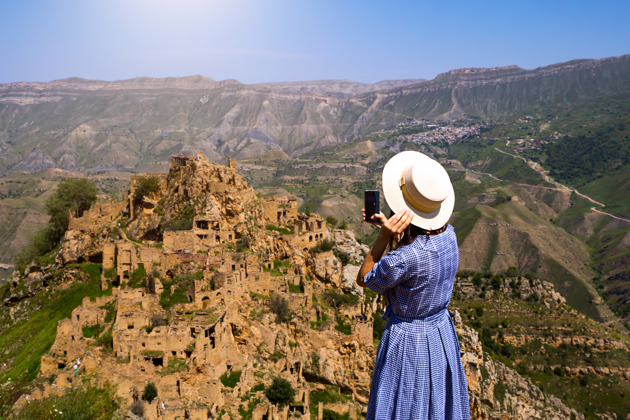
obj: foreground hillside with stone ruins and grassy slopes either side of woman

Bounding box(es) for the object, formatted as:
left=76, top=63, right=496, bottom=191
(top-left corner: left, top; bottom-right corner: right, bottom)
left=6, top=154, right=630, bottom=419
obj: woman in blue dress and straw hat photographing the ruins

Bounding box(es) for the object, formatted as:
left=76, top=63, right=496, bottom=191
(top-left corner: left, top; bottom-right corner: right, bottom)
left=357, top=152, right=470, bottom=420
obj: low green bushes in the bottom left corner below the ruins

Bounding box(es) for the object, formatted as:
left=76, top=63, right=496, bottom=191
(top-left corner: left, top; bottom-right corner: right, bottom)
left=14, top=383, right=121, bottom=420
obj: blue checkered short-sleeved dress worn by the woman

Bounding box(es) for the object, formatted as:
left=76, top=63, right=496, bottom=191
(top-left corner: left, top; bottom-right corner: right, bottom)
left=364, top=226, right=470, bottom=420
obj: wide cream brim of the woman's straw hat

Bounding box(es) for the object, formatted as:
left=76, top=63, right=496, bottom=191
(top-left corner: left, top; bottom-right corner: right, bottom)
left=383, top=151, right=455, bottom=230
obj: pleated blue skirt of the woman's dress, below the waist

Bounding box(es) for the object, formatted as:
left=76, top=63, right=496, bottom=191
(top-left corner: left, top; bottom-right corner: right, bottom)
left=367, top=309, right=470, bottom=420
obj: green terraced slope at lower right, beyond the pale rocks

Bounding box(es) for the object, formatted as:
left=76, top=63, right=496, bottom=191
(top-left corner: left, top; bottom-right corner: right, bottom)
left=451, top=274, right=630, bottom=418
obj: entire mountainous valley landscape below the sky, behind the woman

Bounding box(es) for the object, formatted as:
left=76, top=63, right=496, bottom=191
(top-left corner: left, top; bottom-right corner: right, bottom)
left=0, top=56, right=630, bottom=418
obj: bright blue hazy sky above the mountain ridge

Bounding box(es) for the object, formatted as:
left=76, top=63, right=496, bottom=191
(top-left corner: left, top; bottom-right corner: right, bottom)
left=0, top=0, right=630, bottom=83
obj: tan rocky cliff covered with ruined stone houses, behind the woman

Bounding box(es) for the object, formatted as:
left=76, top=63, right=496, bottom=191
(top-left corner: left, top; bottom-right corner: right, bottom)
left=3, top=153, right=596, bottom=419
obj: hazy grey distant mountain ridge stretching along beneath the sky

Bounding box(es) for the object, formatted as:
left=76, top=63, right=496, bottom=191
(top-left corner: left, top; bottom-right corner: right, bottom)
left=0, top=56, right=630, bottom=173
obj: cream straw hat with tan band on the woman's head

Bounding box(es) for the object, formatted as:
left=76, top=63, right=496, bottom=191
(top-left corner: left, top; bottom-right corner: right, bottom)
left=383, top=151, right=455, bottom=230
